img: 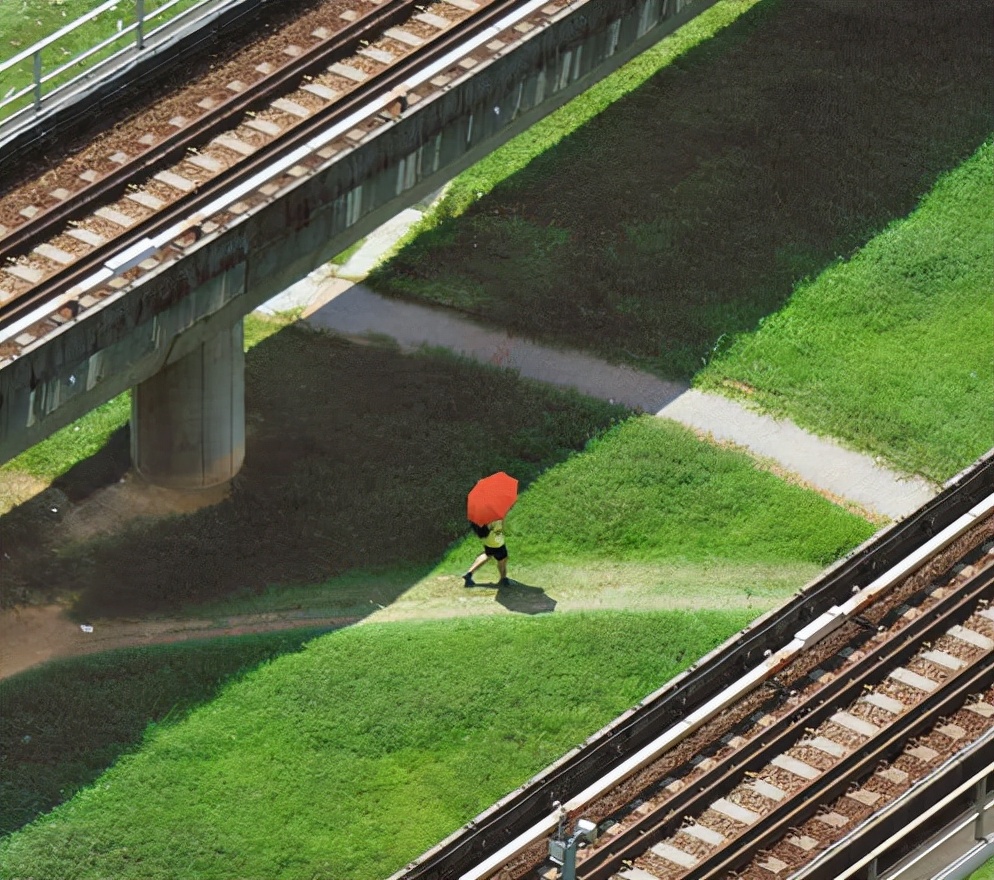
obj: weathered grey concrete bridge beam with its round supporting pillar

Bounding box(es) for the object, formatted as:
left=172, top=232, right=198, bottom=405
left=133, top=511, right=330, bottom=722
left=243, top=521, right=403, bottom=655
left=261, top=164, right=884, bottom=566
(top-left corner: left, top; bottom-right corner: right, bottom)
left=0, top=0, right=714, bottom=489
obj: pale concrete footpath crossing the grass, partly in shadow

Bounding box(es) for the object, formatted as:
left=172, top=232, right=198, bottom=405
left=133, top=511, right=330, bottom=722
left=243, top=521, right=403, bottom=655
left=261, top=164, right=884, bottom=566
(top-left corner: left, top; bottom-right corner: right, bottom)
left=261, top=210, right=940, bottom=520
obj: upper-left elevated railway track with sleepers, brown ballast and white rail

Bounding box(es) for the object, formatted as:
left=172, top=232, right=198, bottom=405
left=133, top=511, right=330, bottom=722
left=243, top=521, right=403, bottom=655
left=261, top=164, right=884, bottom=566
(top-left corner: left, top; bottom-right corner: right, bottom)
left=0, top=0, right=558, bottom=350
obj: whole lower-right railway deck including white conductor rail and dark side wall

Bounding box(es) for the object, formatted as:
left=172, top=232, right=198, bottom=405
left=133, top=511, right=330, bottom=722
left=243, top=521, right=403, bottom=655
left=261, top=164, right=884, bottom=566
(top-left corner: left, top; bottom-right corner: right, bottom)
left=395, top=461, right=994, bottom=880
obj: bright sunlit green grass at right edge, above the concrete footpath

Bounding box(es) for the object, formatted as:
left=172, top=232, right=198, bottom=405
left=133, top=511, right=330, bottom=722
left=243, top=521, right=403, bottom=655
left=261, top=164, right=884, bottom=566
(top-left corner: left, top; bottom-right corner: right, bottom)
left=697, top=141, right=994, bottom=481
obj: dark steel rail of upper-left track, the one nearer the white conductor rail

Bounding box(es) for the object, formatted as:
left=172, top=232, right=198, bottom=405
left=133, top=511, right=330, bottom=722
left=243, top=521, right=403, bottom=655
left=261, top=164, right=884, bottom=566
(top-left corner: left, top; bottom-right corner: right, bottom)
left=0, top=0, right=534, bottom=330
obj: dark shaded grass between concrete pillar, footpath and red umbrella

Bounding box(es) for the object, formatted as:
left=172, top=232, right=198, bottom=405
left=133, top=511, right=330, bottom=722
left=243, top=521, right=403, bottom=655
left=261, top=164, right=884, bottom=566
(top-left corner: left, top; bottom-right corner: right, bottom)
left=0, top=326, right=627, bottom=617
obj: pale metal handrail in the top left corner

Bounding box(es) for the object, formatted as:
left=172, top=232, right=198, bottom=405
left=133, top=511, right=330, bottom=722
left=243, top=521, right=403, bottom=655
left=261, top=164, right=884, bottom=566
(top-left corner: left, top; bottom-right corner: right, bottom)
left=0, top=0, right=217, bottom=119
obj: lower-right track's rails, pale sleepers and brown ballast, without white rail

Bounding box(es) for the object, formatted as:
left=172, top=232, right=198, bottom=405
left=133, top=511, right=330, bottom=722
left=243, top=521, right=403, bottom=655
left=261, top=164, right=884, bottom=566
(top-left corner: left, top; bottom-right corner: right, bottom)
left=578, top=549, right=994, bottom=880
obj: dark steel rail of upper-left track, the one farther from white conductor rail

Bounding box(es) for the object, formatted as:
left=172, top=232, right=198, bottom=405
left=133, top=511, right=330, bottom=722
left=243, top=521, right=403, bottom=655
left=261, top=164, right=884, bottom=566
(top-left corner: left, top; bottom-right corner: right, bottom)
left=0, top=0, right=418, bottom=264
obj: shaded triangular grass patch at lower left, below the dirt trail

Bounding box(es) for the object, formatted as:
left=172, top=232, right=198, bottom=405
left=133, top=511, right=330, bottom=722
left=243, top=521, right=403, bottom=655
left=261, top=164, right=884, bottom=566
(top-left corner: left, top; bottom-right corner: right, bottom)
left=0, top=630, right=332, bottom=835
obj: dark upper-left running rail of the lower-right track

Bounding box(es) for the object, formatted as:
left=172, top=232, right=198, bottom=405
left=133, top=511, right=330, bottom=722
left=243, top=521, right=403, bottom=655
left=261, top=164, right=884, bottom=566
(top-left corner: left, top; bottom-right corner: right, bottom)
left=577, top=566, right=994, bottom=880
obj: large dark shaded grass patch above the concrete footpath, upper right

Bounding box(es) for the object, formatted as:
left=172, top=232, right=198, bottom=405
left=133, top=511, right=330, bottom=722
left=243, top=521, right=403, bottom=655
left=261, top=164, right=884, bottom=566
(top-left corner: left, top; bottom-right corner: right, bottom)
left=370, top=0, right=994, bottom=378
